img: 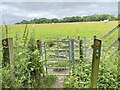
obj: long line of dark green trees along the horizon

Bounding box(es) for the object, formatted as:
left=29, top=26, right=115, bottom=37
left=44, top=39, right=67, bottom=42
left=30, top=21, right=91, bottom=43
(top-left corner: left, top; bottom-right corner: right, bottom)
left=15, top=14, right=118, bottom=24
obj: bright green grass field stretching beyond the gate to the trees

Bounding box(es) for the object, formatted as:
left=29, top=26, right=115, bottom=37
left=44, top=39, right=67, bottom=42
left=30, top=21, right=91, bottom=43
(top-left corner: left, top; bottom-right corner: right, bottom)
left=3, top=21, right=118, bottom=40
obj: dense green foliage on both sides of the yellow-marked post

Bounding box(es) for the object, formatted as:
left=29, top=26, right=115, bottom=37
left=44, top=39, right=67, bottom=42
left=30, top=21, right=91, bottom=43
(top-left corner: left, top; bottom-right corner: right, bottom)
left=64, top=47, right=119, bottom=88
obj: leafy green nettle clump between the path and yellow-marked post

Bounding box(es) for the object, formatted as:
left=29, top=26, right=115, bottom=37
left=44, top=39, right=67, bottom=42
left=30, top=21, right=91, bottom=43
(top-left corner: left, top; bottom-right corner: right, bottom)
left=64, top=60, right=91, bottom=88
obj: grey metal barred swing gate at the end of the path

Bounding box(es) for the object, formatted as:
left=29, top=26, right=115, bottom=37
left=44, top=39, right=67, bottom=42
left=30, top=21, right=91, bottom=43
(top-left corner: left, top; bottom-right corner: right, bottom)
left=44, top=39, right=74, bottom=75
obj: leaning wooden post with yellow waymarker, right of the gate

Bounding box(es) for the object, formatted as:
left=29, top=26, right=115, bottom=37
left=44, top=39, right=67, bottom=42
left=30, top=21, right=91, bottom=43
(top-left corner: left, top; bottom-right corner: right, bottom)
left=91, top=36, right=102, bottom=88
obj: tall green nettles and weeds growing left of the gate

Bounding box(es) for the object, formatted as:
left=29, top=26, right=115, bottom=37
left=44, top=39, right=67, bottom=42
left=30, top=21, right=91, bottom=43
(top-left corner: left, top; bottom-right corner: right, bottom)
left=2, top=25, right=44, bottom=88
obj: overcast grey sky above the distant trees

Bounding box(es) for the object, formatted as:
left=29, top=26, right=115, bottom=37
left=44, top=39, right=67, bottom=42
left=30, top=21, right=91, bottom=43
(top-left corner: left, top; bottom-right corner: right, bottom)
left=0, top=2, right=118, bottom=24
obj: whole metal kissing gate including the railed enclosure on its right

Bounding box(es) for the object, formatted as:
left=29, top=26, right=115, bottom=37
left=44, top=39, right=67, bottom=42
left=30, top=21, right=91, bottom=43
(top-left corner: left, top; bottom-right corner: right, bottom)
left=37, top=36, right=92, bottom=75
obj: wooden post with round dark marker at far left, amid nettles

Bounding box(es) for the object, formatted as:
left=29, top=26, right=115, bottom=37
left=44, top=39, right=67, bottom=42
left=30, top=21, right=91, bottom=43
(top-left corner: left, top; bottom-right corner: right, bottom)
left=2, top=38, right=14, bottom=87
